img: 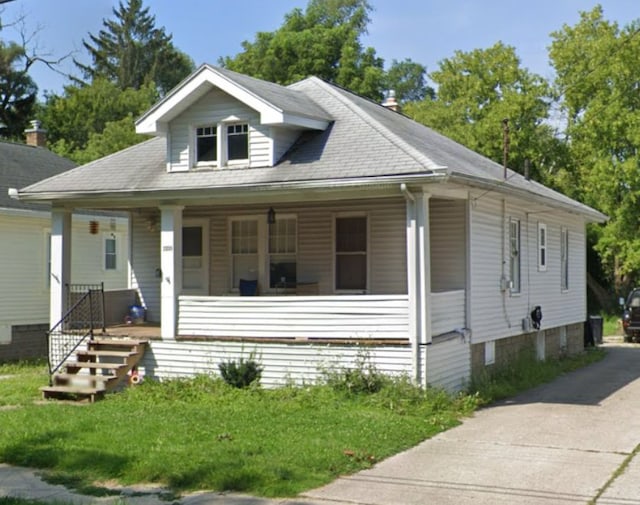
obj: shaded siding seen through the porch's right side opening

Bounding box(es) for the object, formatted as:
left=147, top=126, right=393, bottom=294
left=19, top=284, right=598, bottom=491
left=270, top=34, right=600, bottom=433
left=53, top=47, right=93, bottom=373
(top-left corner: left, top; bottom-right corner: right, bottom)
left=429, top=198, right=467, bottom=292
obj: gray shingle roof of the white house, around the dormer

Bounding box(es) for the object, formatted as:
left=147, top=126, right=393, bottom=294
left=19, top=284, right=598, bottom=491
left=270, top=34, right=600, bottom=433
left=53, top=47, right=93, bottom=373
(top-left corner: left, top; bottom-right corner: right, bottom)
left=21, top=69, right=598, bottom=218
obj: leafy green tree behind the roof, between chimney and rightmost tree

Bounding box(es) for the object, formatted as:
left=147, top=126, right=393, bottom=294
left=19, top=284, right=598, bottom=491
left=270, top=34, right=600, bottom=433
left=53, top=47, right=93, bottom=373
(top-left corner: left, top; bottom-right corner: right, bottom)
left=404, top=42, right=561, bottom=180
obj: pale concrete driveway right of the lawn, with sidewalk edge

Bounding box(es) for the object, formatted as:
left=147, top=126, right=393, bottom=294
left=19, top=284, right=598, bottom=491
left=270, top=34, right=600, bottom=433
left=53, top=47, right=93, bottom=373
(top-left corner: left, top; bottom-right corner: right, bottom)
left=0, top=344, right=640, bottom=505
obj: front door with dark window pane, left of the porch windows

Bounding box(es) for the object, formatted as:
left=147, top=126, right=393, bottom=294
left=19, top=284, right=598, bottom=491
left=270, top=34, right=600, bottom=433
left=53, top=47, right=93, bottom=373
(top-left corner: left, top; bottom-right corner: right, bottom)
left=182, top=219, right=209, bottom=296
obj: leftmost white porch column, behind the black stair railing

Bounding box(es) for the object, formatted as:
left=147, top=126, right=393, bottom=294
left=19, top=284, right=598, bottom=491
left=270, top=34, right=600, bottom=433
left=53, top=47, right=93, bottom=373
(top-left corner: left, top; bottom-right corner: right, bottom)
left=49, top=207, right=71, bottom=328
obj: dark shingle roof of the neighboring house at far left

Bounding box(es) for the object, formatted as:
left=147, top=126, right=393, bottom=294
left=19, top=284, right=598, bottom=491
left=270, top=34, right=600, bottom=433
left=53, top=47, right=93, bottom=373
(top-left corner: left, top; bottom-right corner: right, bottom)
left=0, top=142, right=76, bottom=210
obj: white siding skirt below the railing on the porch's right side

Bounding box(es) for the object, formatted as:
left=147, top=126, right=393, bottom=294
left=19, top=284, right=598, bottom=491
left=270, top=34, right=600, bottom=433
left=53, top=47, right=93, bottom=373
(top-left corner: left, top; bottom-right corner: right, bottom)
left=427, top=335, right=471, bottom=392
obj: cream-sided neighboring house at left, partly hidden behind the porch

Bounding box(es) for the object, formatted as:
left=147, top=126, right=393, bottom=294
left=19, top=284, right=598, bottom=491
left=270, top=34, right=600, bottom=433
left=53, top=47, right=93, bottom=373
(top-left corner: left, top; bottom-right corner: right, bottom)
left=0, top=122, right=128, bottom=362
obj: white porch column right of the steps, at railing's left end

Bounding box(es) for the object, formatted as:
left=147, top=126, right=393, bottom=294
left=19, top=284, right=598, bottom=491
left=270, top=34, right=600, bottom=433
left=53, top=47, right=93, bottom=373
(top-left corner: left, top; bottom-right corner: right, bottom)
left=160, top=205, right=184, bottom=340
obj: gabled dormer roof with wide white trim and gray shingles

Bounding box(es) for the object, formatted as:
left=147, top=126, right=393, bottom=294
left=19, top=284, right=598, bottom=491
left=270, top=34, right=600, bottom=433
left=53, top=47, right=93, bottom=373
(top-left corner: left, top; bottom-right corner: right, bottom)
left=136, top=65, right=331, bottom=135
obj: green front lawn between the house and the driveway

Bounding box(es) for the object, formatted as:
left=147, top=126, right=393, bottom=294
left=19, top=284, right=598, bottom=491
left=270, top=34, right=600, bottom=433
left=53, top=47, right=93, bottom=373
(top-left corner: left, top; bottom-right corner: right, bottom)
left=0, top=351, right=603, bottom=505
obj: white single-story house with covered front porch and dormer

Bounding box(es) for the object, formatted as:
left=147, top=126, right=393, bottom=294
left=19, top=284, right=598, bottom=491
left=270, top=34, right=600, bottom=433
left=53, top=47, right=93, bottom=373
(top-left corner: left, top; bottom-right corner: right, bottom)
left=17, top=65, right=605, bottom=390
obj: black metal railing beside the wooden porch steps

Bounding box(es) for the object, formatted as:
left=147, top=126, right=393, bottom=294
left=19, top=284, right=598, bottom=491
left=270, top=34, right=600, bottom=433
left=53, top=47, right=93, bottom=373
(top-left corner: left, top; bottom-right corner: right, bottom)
left=47, top=283, right=106, bottom=381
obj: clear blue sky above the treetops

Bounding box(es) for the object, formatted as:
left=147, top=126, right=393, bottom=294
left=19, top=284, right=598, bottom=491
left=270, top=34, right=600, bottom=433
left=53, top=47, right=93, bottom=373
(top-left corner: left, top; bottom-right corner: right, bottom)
left=0, top=0, right=640, bottom=96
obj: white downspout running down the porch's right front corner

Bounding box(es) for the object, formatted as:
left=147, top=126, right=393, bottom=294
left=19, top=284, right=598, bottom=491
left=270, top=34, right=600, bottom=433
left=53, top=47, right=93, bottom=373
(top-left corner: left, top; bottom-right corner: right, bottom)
left=400, top=183, right=421, bottom=385
